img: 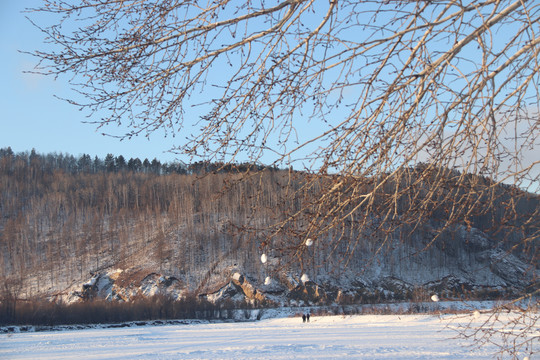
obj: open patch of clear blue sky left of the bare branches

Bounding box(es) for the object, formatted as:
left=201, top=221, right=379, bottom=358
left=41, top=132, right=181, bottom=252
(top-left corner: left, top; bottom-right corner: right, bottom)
left=0, top=0, right=177, bottom=161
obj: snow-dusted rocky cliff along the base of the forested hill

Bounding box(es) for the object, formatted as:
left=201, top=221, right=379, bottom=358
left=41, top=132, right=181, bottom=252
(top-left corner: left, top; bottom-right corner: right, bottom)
left=57, top=227, right=539, bottom=305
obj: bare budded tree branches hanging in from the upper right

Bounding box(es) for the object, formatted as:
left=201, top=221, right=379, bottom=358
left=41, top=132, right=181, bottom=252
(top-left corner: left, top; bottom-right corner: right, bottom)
left=28, top=0, right=540, bottom=358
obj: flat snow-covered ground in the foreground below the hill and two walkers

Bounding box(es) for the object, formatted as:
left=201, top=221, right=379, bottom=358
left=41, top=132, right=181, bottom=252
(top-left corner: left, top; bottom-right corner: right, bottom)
left=0, top=315, right=524, bottom=360
